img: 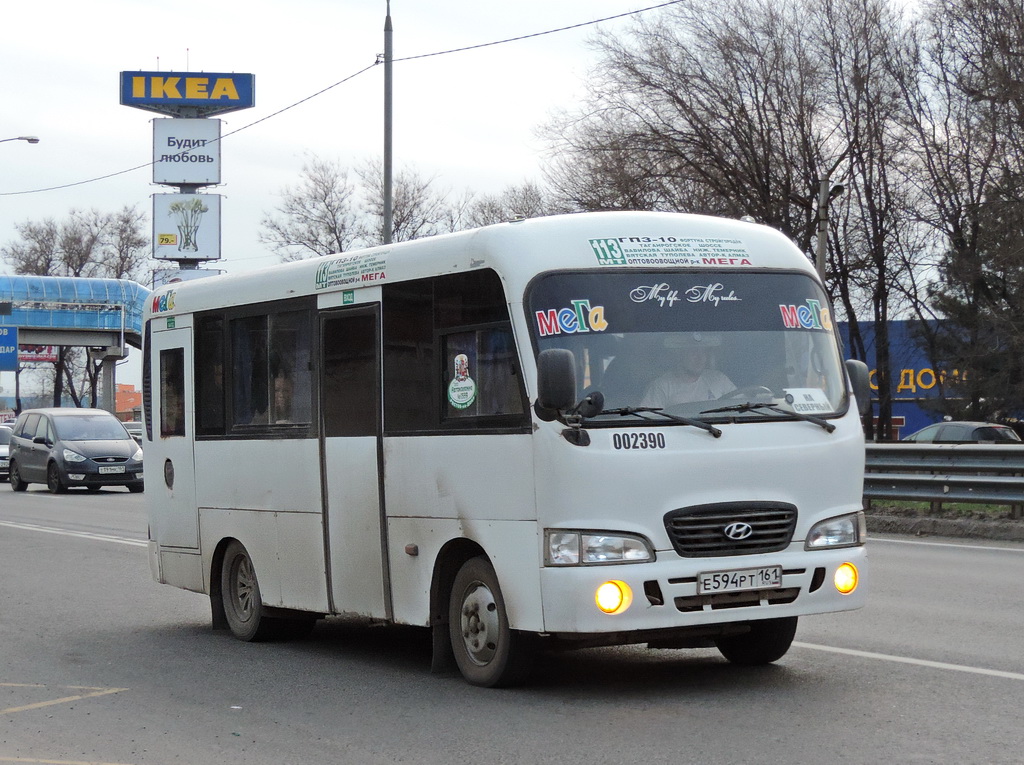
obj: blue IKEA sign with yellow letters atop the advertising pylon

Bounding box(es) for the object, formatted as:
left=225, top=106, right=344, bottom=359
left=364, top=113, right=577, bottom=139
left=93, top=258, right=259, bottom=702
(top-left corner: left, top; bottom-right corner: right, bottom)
left=121, top=72, right=256, bottom=117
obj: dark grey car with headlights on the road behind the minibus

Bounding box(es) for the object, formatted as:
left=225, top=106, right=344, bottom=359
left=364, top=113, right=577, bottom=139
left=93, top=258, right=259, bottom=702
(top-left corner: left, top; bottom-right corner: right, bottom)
left=10, top=409, right=144, bottom=494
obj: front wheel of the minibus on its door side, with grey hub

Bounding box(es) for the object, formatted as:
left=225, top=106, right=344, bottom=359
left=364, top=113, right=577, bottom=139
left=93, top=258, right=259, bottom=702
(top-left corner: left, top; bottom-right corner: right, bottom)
left=449, top=556, right=534, bottom=688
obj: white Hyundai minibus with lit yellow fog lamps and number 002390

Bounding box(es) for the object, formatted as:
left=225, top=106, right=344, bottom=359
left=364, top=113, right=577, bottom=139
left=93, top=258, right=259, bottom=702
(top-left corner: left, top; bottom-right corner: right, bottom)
left=143, top=212, right=867, bottom=686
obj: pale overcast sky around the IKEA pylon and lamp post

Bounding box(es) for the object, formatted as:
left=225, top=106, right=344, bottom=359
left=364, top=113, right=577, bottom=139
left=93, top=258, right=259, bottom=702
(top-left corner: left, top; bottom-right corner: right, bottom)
left=0, top=0, right=659, bottom=280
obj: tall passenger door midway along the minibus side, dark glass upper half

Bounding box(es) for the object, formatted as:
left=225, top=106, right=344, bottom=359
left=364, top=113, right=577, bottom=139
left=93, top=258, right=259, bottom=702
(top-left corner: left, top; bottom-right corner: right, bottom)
left=319, top=306, right=391, bottom=618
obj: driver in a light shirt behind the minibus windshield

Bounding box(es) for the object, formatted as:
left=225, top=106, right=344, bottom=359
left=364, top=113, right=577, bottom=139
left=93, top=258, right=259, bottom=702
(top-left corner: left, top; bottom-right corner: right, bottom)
left=641, top=332, right=736, bottom=408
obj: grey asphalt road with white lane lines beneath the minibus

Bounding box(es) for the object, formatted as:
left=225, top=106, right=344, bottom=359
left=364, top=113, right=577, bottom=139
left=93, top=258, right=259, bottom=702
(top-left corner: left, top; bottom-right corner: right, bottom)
left=0, top=485, right=1024, bottom=765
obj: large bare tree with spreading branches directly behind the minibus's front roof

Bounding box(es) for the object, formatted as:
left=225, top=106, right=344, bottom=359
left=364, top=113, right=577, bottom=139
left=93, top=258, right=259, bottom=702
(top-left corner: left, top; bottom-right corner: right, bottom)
left=550, top=0, right=827, bottom=249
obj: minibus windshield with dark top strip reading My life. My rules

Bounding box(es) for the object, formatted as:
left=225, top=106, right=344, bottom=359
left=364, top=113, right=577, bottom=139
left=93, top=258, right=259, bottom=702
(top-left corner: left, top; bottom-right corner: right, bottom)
left=527, top=271, right=847, bottom=424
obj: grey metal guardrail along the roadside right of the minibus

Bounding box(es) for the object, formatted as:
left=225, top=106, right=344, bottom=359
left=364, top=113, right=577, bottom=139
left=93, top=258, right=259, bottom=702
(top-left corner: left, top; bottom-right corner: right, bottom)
left=864, top=443, right=1024, bottom=518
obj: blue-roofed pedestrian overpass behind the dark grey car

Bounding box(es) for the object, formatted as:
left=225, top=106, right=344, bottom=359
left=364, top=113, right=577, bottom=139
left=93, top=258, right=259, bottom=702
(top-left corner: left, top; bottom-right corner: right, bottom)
left=0, top=274, right=150, bottom=412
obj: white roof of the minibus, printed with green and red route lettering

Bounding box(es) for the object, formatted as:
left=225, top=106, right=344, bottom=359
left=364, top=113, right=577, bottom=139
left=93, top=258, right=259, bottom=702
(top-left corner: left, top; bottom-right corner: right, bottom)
left=146, top=212, right=814, bottom=315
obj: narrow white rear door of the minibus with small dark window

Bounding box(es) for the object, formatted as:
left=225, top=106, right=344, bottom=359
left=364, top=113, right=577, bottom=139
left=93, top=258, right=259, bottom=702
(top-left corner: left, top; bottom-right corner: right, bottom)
left=142, top=327, right=199, bottom=550
